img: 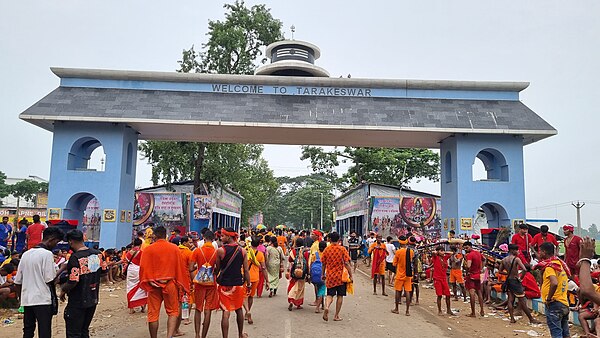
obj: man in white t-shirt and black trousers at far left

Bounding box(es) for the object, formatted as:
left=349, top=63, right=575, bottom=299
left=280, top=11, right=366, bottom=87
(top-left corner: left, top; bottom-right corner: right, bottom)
left=15, top=227, right=64, bottom=338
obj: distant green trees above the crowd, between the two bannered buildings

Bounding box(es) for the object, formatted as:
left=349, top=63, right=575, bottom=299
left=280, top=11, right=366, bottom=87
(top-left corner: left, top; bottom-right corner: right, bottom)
left=264, top=174, right=334, bottom=231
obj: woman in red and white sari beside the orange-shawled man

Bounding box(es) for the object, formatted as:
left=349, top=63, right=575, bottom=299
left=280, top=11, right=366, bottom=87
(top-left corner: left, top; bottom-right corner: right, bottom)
left=125, top=238, right=148, bottom=313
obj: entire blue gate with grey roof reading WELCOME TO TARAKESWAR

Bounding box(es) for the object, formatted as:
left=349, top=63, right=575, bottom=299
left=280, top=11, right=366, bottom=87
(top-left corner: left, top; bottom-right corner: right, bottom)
left=20, top=40, right=557, bottom=247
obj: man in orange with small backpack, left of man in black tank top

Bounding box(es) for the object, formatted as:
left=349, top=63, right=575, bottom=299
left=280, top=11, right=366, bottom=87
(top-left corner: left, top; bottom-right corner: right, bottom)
left=189, top=230, right=219, bottom=338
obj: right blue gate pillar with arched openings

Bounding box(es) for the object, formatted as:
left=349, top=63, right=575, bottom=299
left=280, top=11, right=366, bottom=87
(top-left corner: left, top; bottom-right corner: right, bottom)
left=440, top=134, right=525, bottom=235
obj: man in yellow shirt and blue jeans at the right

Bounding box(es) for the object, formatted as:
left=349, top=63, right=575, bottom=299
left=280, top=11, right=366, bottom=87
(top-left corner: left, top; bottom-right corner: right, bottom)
left=536, top=242, right=570, bottom=338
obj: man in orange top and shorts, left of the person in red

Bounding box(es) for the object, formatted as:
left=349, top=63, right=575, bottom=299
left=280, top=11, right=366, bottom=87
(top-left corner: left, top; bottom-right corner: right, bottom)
left=392, top=236, right=415, bottom=316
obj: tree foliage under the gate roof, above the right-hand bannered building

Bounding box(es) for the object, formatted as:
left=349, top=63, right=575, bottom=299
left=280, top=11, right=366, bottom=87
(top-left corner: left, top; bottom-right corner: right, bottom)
left=301, top=146, right=440, bottom=190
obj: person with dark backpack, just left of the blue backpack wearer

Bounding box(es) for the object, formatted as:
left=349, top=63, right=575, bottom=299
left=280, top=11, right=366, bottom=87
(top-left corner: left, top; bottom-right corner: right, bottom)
left=285, top=237, right=309, bottom=311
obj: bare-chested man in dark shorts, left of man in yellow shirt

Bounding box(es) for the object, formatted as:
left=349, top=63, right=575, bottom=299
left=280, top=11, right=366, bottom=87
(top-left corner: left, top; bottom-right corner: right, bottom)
left=500, top=244, right=539, bottom=324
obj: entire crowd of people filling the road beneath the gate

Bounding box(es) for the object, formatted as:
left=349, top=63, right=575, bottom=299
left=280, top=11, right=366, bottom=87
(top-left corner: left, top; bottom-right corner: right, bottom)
left=0, top=217, right=600, bottom=337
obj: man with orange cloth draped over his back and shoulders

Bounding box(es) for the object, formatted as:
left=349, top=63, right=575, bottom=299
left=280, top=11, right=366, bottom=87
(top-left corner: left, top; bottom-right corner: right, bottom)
left=140, top=226, right=190, bottom=338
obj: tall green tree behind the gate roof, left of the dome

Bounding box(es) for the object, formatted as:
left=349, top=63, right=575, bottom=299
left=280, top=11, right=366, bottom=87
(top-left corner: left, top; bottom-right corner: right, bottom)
left=140, top=1, right=283, bottom=227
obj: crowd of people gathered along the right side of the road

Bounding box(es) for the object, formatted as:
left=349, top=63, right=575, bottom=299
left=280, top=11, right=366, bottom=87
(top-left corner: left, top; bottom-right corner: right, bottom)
left=348, top=224, right=600, bottom=337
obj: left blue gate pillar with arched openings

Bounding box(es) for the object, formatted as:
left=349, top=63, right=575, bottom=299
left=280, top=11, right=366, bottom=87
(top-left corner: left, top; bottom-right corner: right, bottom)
left=48, top=122, right=138, bottom=248
